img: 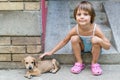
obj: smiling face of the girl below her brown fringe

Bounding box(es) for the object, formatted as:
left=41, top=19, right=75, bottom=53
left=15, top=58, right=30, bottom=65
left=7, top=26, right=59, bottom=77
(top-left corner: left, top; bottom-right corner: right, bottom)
left=76, top=10, right=91, bottom=26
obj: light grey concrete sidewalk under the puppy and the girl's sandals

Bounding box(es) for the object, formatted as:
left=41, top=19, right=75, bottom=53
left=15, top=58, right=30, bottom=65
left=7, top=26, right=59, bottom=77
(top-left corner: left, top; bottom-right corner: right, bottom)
left=0, top=65, right=120, bottom=80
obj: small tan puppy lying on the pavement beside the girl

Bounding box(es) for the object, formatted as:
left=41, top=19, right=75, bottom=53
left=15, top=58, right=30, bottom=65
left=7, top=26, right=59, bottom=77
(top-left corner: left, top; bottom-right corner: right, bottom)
left=23, top=56, right=60, bottom=79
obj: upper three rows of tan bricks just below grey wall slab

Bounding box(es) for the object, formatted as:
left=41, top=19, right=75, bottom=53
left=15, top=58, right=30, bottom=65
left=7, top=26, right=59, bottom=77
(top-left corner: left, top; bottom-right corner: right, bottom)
left=0, top=37, right=41, bottom=61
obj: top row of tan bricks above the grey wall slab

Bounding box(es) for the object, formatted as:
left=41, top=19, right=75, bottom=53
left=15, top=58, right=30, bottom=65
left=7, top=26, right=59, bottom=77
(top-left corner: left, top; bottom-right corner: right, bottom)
left=0, top=0, right=40, bottom=10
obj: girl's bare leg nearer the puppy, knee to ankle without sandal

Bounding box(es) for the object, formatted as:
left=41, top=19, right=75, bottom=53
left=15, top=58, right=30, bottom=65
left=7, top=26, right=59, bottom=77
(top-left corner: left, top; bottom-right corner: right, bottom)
left=71, top=35, right=83, bottom=64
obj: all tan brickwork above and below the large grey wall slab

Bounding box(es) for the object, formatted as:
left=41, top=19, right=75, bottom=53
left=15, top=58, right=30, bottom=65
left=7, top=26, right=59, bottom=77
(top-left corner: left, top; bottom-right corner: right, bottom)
left=0, top=0, right=42, bottom=68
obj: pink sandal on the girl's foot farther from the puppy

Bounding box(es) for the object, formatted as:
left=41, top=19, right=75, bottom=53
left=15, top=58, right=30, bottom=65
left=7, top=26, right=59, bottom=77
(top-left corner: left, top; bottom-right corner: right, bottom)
left=91, top=63, right=102, bottom=76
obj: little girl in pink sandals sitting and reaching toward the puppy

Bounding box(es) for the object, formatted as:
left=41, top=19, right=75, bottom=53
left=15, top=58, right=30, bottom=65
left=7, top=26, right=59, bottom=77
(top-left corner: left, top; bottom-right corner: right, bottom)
left=40, top=1, right=111, bottom=75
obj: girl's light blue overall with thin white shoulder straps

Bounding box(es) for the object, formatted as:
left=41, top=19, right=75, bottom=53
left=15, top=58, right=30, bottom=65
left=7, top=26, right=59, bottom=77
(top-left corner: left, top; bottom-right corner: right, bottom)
left=76, top=24, right=96, bottom=52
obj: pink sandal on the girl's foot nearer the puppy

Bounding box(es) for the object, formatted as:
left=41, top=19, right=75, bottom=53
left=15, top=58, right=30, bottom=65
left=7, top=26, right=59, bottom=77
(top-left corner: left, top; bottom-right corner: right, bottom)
left=71, top=63, right=85, bottom=74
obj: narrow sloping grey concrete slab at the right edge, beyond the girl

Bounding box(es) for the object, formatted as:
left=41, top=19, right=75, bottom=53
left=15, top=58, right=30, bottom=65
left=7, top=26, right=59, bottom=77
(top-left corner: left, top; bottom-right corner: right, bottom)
left=103, top=1, right=120, bottom=52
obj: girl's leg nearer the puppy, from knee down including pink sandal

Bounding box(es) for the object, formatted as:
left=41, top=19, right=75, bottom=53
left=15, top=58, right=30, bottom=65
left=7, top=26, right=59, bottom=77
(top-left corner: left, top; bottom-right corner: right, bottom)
left=71, top=36, right=85, bottom=74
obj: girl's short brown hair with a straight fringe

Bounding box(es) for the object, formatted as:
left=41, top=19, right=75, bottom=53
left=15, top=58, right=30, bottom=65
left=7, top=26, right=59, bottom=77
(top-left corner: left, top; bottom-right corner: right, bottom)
left=74, top=1, right=95, bottom=23
